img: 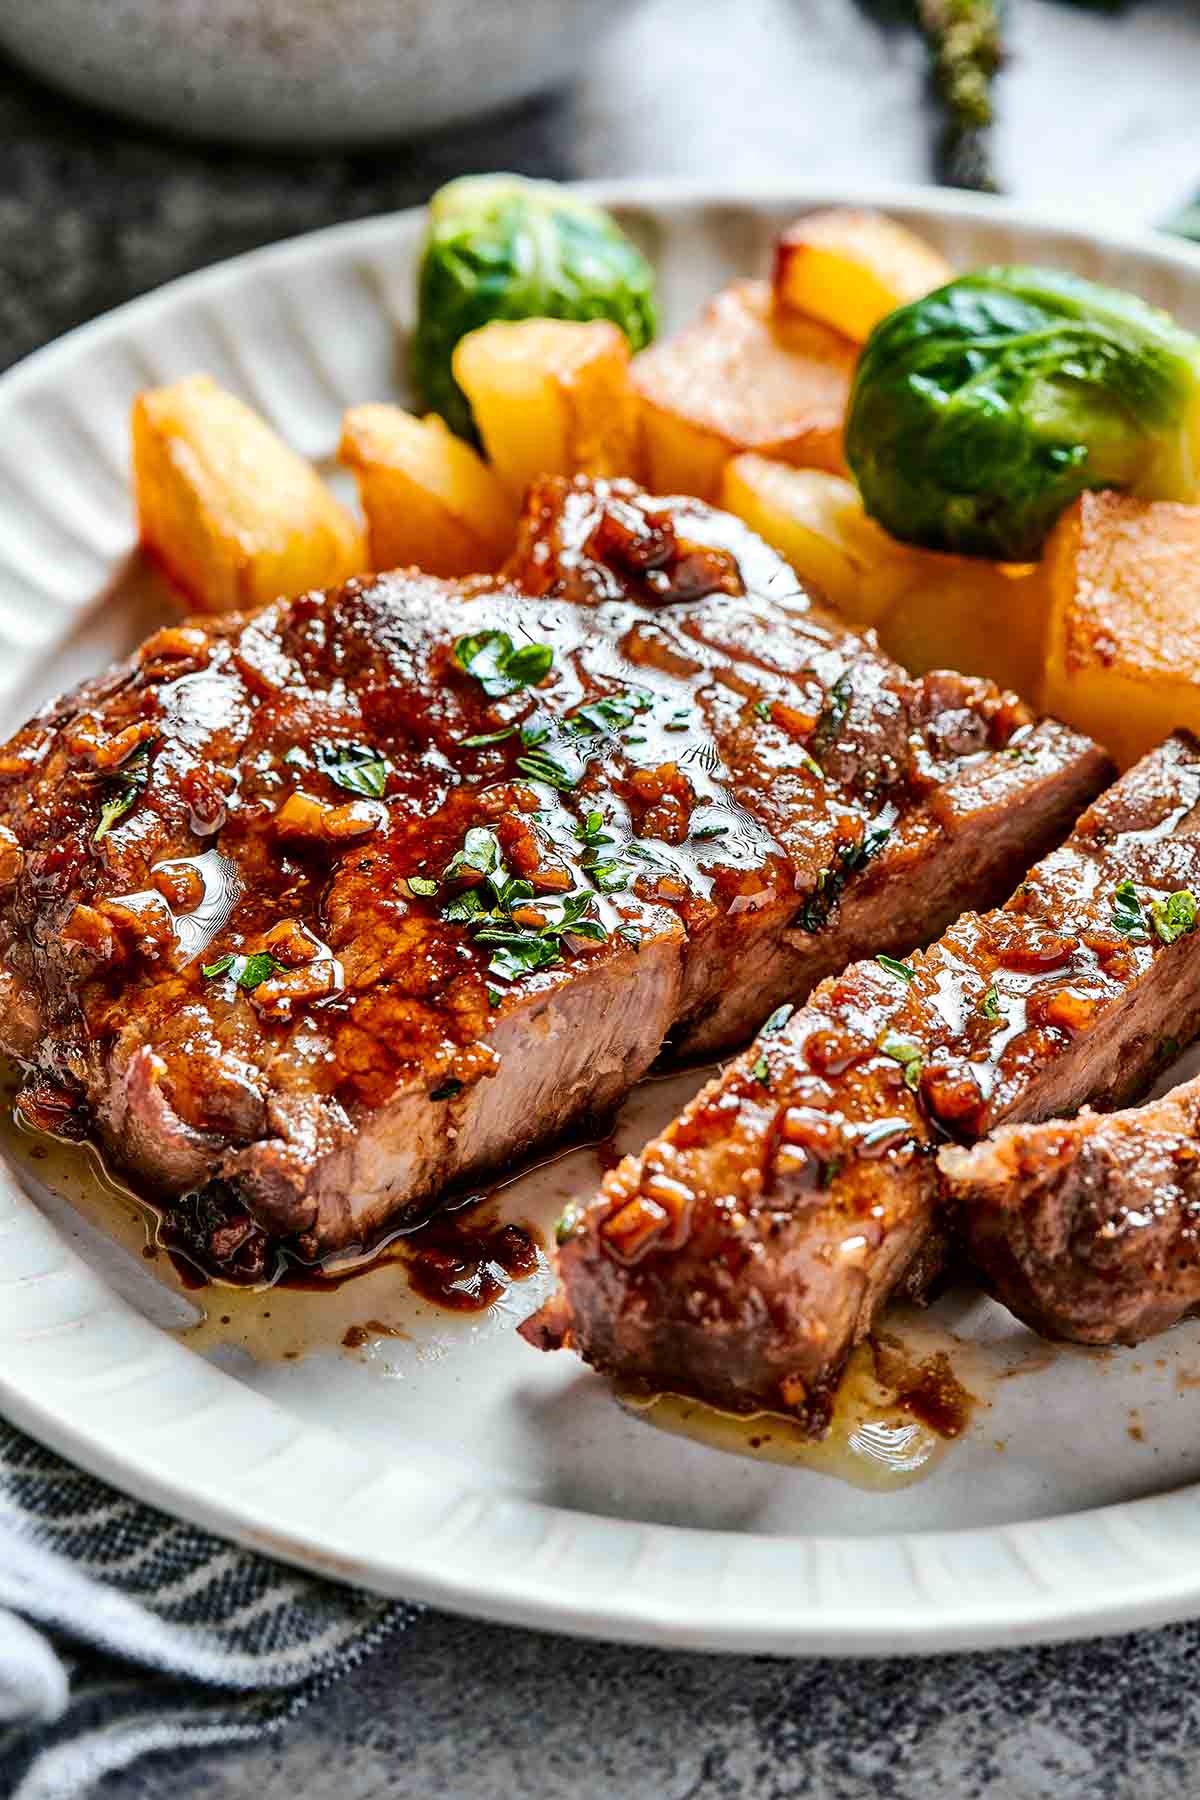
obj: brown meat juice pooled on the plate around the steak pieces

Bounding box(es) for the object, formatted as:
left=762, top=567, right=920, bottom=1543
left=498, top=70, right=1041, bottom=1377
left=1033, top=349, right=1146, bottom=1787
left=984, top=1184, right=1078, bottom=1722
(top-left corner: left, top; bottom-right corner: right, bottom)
left=4, top=1071, right=995, bottom=1490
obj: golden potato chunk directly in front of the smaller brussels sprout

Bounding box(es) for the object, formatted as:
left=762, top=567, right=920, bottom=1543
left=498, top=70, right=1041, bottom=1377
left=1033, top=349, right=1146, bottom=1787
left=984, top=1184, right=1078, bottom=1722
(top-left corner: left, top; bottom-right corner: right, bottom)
left=453, top=319, right=640, bottom=504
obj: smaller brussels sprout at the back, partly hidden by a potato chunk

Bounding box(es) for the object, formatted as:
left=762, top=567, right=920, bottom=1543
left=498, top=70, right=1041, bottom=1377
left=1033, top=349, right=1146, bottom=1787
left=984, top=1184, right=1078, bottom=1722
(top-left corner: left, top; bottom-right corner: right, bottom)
left=410, top=175, right=655, bottom=439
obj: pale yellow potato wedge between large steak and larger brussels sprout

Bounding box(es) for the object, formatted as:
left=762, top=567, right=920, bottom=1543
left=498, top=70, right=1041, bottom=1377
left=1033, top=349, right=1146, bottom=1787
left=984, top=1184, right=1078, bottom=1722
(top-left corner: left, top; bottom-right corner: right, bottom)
left=718, top=452, right=912, bottom=625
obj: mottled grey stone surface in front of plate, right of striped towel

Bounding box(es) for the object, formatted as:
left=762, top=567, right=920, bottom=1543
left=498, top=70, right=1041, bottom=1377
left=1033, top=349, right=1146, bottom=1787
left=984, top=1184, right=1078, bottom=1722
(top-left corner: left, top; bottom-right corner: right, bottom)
left=103, top=1616, right=1200, bottom=1800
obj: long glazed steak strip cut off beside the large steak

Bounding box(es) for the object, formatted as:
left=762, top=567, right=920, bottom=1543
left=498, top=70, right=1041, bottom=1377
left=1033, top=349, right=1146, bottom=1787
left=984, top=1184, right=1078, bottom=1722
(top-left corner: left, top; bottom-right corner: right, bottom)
left=525, top=734, right=1200, bottom=1429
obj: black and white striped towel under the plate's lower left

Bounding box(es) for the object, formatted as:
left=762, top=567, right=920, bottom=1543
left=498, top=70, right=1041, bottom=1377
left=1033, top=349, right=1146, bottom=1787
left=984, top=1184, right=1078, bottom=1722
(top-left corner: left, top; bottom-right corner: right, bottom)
left=0, top=1420, right=412, bottom=1800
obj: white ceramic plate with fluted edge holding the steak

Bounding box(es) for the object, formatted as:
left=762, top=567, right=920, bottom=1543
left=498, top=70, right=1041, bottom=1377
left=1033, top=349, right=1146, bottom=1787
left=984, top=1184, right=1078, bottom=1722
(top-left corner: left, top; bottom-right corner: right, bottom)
left=0, top=185, right=1200, bottom=1652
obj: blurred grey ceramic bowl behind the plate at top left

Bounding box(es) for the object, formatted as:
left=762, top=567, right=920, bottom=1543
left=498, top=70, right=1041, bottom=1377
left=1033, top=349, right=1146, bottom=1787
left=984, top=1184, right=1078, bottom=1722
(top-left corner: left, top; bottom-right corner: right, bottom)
left=0, top=0, right=631, bottom=148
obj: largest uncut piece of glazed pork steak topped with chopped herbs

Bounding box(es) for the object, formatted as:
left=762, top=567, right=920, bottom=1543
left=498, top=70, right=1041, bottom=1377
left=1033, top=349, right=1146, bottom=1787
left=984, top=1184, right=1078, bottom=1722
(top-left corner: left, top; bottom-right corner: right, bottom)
left=0, top=482, right=1105, bottom=1273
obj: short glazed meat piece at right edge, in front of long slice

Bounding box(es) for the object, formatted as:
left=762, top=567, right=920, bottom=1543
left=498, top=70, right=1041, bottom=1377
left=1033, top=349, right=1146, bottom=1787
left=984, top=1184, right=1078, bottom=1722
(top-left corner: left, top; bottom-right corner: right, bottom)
left=939, top=1080, right=1200, bottom=1345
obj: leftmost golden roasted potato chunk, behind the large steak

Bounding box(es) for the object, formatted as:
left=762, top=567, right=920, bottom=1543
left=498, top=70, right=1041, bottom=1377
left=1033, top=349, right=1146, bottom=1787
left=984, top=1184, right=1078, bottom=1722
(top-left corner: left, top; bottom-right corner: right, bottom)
left=131, top=374, right=367, bottom=612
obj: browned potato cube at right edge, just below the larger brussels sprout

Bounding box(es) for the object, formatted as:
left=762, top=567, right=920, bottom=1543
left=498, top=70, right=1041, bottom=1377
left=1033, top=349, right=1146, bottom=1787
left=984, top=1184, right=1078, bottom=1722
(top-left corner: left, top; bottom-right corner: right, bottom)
left=1042, top=493, right=1200, bottom=767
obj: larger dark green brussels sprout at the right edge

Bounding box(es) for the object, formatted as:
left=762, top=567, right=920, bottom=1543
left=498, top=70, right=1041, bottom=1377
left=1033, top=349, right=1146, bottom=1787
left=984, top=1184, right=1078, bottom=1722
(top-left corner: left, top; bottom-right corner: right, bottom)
left=846, top=268, right=1200, bottom=562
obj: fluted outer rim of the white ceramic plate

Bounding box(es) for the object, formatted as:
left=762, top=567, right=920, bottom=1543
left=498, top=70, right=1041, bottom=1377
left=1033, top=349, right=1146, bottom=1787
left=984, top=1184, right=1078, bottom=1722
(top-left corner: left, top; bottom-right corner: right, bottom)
left=0, top=178, right=1200, bottom=1656
